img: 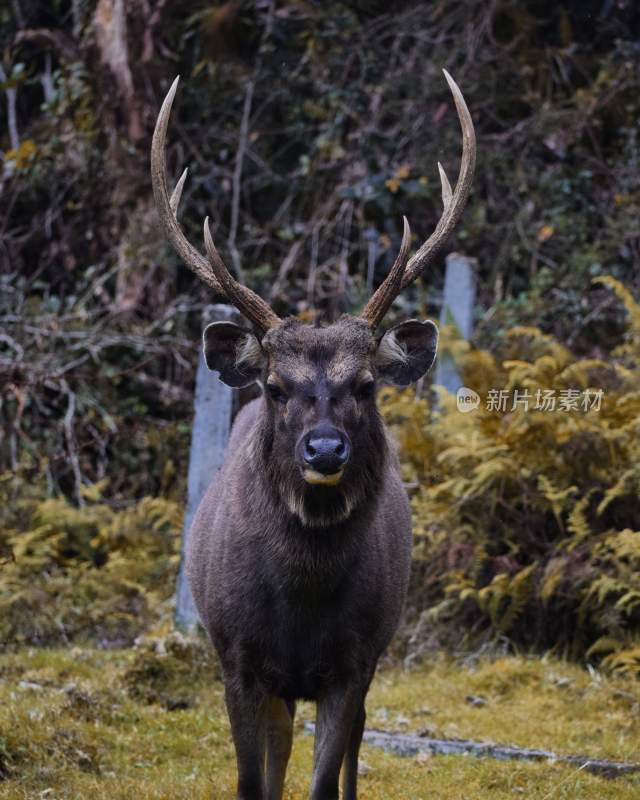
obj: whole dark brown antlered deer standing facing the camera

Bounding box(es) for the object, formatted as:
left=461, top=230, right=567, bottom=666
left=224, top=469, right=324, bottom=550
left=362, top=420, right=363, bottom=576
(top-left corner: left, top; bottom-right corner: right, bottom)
left=151, top=71, right=476, bottom=800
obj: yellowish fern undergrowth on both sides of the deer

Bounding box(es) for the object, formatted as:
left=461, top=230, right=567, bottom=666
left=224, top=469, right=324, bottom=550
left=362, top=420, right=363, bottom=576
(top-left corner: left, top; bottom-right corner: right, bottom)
left=0, top=278, right=640, bottom=675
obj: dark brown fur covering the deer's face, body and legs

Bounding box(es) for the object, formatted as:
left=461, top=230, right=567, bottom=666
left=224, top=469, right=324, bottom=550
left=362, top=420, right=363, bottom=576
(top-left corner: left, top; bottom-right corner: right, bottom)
left=187, top=317, right=433, bottom=800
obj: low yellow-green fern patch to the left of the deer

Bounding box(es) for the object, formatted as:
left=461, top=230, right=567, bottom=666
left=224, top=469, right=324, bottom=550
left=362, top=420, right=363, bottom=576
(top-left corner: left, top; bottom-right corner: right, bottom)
left=0, top=476, right=181, bottom=648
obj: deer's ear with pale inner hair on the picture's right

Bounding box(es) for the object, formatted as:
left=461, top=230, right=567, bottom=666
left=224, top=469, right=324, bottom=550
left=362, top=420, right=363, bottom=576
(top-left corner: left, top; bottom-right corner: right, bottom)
left=376, top=319, right=438, bottom=386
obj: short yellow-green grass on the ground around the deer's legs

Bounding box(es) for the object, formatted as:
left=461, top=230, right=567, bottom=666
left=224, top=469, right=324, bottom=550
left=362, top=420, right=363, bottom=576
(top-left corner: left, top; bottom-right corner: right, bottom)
left=0, top=640, right=640, bottom=800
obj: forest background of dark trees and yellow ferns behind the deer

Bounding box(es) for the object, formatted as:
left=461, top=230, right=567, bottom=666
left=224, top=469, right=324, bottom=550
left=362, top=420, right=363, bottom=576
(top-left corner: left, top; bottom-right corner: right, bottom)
left=0, top=0, right=640, bottom=675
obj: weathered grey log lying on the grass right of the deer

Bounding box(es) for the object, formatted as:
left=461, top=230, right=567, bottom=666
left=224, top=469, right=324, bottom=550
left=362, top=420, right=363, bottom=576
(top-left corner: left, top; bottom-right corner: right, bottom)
left=304, top=722, right=640, bottom=778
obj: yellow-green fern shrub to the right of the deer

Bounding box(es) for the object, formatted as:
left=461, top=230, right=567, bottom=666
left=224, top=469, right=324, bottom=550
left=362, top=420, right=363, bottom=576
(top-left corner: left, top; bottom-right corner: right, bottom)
left=381, top=278, right=640, bottom=672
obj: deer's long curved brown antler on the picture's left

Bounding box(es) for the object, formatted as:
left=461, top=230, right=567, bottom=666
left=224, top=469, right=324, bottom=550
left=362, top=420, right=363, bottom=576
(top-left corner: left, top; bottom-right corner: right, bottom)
left=151, top=76, right=280, bottom=332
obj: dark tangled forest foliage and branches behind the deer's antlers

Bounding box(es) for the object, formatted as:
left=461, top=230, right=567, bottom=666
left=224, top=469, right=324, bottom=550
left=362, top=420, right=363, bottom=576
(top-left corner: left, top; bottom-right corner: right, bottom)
left=0, top=0, right=640, bottom=498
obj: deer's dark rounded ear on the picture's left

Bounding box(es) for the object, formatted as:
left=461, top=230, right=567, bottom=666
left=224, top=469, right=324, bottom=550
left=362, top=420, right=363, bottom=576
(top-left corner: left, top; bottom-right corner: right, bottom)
left=202, top=322, right=265, bottom=389
